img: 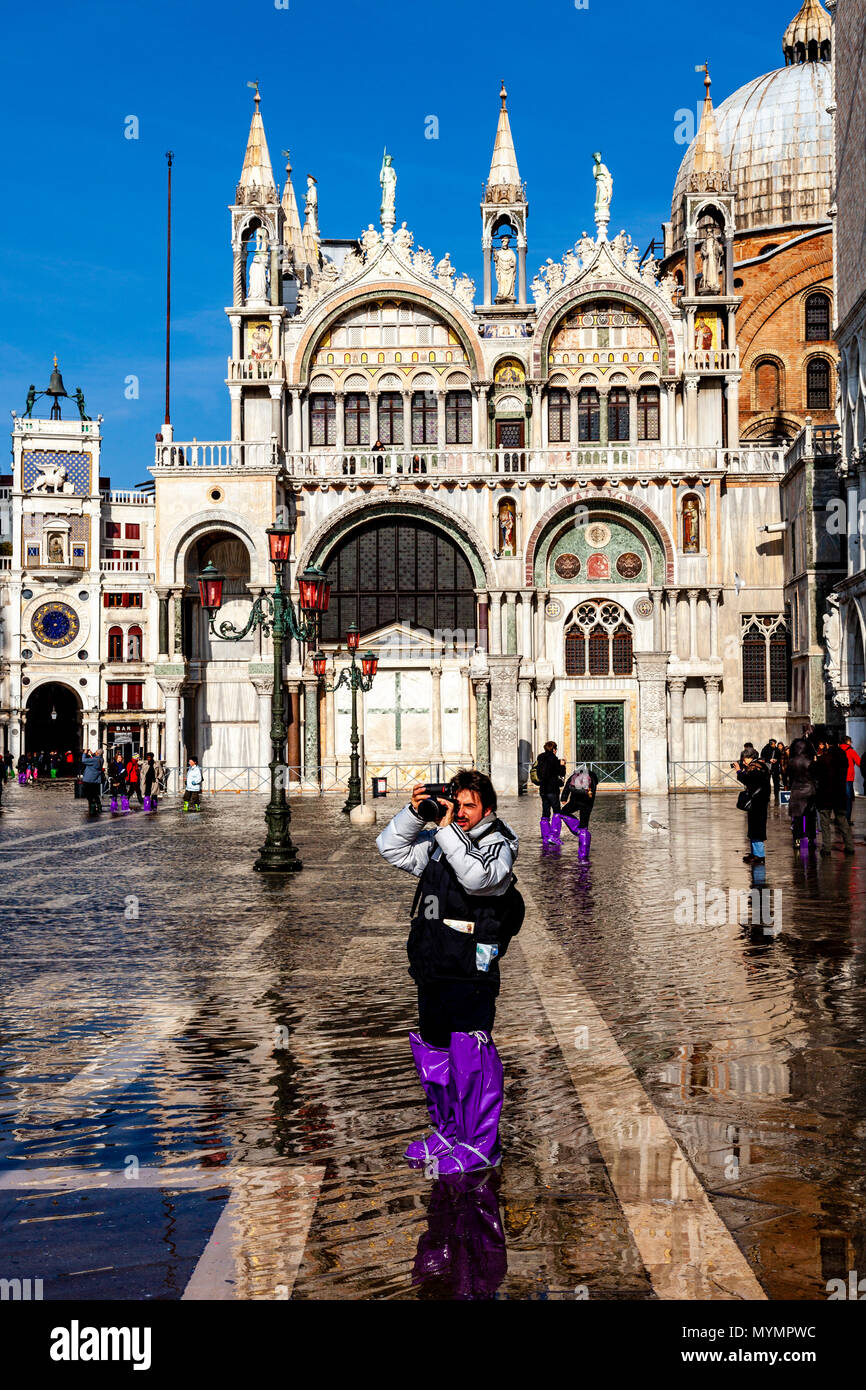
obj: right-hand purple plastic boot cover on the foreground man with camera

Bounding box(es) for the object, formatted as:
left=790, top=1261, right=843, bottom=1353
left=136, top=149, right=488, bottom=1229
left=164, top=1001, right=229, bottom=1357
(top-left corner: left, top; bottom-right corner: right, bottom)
left=438, top=1033, right=505, bottom=1177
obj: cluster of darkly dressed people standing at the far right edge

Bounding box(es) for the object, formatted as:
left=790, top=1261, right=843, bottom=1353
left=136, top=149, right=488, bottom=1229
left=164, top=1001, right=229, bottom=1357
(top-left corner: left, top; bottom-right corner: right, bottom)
left=731, top=726, right=860, bottom=863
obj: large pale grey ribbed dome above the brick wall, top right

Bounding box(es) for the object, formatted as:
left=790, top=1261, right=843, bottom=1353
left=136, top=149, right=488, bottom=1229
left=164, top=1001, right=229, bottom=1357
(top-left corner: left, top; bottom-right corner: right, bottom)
left=671, top=60, right=833, bottom=246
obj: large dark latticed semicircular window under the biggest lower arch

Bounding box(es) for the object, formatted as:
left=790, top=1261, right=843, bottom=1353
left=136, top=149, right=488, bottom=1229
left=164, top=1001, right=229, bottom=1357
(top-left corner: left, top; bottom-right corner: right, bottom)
left=321, top=518, right=475, bottom=639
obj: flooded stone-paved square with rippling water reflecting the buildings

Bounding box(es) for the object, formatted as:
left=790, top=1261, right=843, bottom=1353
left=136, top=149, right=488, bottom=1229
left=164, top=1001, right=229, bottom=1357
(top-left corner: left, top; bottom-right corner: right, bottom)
left=0, top=785, right=866, bottom=1300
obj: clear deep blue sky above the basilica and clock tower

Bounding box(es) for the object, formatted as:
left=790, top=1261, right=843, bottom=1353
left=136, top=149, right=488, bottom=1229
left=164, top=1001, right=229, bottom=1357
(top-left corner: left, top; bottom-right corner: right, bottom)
left=0, top=0, right=798, bottom=487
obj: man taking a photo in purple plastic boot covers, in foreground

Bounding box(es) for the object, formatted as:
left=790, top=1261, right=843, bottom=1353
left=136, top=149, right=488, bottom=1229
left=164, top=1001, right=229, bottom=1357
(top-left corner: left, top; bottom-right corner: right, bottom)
left=377, top=771, right=524, bottom=1175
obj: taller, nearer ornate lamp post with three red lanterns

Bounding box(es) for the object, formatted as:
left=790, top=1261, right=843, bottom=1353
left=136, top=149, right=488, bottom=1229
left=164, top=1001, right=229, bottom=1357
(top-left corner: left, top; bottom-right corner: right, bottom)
left=199, top=525, right=331, bottom=873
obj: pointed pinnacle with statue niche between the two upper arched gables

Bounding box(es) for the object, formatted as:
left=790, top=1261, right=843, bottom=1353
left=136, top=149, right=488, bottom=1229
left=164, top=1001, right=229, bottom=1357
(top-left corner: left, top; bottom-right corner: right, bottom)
left=481, top=82, right=530, bottom=307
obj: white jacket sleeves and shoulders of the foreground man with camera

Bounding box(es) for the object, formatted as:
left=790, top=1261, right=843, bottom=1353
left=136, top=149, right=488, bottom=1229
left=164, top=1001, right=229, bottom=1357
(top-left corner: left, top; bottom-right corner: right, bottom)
left=375, top=806, right=518, bottom=897
